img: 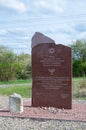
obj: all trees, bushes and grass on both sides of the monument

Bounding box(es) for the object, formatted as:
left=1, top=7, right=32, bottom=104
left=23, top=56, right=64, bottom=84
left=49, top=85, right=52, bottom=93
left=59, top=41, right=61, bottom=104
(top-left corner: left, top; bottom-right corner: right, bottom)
left=0, top=40, right=86, bottom=99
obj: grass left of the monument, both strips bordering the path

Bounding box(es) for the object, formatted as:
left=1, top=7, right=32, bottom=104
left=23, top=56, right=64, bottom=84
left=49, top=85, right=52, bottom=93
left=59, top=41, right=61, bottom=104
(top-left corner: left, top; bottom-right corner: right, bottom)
left=0, top=79, right=32, bottom=98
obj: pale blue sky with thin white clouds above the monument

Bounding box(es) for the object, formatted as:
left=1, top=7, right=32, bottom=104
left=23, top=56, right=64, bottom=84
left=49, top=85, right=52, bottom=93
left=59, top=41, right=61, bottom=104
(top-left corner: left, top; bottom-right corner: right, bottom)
left=0, top=0, right=86, bottom=53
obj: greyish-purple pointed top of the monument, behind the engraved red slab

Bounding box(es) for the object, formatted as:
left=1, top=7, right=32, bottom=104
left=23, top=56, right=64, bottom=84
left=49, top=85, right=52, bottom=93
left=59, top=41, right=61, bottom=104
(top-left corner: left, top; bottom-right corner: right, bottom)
left=31, top=32, right=55, bottom=48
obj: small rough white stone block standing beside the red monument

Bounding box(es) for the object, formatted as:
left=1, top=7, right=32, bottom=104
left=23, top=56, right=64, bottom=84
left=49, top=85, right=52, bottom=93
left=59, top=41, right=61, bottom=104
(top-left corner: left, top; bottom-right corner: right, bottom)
left=9, top=93, right=23, bottom=113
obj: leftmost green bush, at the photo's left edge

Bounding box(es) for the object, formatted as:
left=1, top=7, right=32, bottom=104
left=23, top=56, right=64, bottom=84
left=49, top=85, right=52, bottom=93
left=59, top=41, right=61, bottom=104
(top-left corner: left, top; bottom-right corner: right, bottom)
left=0, top=47, right=19, bottom=81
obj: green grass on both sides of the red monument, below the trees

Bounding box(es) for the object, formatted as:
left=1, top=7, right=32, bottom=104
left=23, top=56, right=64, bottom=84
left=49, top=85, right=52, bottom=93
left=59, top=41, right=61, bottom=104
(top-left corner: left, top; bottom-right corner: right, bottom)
left=0, top=77, right=86, bottom=100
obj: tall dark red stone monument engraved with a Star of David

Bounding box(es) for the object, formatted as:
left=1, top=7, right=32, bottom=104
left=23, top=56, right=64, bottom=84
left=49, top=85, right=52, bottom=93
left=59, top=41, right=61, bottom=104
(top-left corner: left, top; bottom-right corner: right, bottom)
left=32, top=33, right=72, bottom=109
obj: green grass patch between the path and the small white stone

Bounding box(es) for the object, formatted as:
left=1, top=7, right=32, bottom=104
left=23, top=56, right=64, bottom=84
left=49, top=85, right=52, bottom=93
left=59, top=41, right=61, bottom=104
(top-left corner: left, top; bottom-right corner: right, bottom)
left=0, top=86, right=31, bottom=98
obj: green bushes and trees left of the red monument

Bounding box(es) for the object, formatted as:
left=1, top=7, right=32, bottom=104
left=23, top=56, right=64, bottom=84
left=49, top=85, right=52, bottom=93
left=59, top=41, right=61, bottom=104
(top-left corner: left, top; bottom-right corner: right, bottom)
left=0, top=46, right=31, bottom=81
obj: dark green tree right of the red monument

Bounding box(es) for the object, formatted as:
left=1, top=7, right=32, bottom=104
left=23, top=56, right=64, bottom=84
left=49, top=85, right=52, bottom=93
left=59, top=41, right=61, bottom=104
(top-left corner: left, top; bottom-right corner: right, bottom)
left=71, top=40, right=86, bottom=77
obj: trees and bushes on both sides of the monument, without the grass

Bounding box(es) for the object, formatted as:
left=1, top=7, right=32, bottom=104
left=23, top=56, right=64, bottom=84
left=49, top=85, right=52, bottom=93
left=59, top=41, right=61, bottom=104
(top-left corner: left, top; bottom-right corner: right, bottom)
left=0, top=40, right=86, bottom=81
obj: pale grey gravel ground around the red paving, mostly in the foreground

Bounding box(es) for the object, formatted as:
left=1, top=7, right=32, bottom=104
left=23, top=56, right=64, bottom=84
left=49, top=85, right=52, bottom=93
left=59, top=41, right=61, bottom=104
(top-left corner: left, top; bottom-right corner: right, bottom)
left=0, top=96, right=86, bottom=130
